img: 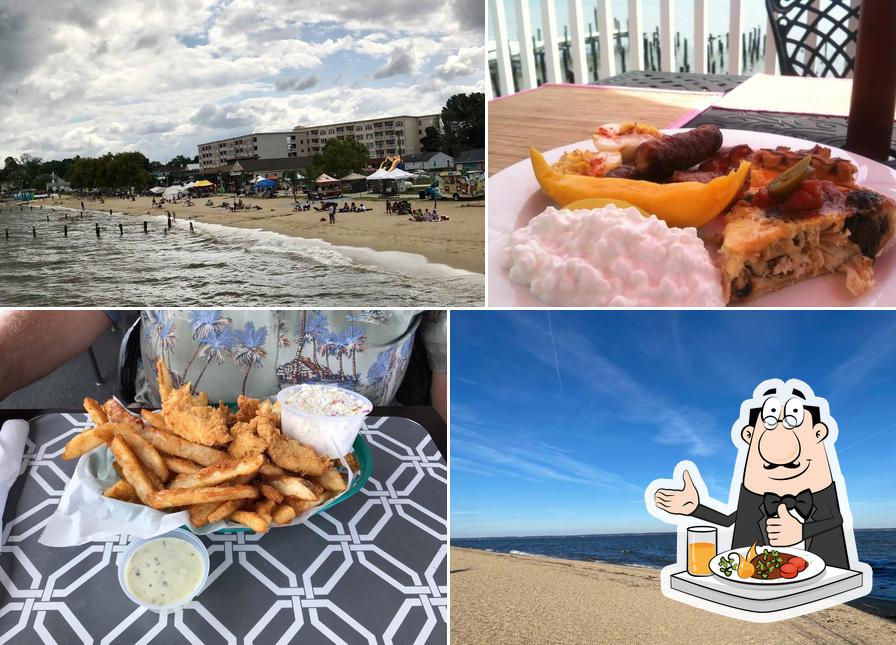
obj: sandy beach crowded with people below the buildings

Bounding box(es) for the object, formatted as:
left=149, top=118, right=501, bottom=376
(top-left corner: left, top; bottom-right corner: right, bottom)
left=50, top=195, right=485, bottom=273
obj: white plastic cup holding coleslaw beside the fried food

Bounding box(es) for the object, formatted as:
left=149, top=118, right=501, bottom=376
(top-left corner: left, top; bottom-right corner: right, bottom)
left=277, top=384, right=373, bottom=459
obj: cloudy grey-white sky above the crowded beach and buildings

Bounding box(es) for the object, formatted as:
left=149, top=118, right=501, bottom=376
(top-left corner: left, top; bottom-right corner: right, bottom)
left=0, top=0, right=485, bottom=163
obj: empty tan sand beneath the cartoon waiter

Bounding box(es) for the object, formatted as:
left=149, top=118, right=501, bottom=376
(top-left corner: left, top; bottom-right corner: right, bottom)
left=451, top=548, right=896, bottom=645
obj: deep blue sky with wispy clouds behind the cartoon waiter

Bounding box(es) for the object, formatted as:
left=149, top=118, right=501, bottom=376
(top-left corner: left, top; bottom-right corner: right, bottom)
left=450, top=310, right=896, bottom=538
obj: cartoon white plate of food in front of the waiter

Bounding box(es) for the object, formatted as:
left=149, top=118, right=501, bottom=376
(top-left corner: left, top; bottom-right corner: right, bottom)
left=709, top=546, right=825, bottom=586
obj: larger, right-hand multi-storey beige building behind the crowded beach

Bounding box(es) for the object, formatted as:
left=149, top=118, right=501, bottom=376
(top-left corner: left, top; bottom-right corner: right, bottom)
left=289, top=114, right=439, bottom=159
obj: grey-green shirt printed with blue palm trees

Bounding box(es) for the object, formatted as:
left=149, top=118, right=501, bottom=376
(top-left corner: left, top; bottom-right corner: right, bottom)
left=137, top=309, right=447, bottom=406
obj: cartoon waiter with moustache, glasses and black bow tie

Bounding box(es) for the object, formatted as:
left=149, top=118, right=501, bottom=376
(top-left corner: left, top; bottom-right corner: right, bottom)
left=654, top=380, right=849, bottom=569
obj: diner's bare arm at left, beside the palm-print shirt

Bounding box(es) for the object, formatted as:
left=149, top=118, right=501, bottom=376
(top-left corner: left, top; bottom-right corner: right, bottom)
left=0, top=310, right=112, bottom=400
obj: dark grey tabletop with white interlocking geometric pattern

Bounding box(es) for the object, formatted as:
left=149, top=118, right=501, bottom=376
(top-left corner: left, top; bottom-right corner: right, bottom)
left=0, top=414, right=448, bottom=645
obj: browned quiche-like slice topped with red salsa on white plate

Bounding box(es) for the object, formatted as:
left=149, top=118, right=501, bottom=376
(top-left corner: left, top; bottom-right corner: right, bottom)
left=719, top=180, right=896, bottom=303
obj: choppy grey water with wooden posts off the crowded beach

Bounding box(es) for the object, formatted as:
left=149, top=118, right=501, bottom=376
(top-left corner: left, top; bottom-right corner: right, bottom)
left=0, top=206, right=485, bottom=307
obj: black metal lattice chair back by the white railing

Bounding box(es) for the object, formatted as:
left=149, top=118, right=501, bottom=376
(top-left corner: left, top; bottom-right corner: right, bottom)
left=765, top=0, right=860, bottom=78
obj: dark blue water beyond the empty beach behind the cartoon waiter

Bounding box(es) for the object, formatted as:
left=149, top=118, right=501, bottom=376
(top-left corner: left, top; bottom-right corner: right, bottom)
left=451, top=529, right=896, bottom=601
